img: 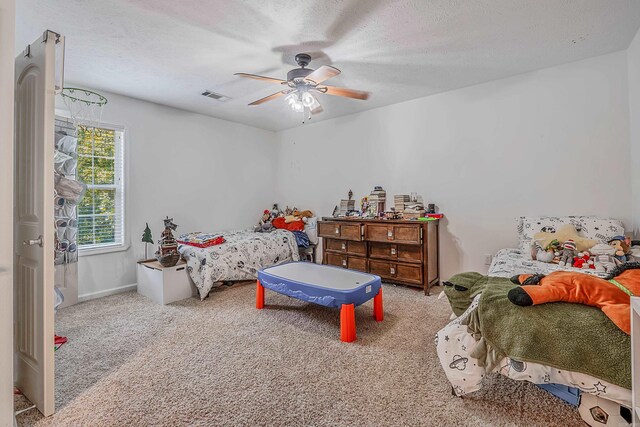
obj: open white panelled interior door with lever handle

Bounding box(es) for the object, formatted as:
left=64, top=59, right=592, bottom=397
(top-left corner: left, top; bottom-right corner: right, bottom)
left=14, top=31, right=57, bottom=416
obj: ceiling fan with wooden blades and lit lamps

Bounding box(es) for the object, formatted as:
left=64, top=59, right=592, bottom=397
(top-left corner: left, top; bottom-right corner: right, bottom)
left=235, top=53, right=369, bottom=117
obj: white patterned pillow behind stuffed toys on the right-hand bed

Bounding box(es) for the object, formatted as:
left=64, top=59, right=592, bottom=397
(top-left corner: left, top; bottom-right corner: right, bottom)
left=518, top=216, right=624, bottom=259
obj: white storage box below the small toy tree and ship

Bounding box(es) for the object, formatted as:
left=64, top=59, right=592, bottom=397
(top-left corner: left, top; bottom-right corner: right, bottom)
left=138, top=260, right=197, bottom=304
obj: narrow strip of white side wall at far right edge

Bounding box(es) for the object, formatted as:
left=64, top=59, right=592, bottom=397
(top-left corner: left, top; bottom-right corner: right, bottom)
left=627, top=31, right=640, bottom=238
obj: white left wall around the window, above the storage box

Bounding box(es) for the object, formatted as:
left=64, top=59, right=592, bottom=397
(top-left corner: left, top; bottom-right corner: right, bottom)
left=65, top=91, right=276, bottom=297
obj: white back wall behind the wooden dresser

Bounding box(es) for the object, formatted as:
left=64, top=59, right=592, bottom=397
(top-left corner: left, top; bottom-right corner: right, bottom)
left=277, top=52, right=631, bottom=278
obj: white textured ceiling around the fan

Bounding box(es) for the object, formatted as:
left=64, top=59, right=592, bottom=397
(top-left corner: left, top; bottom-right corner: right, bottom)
left=16, top=0, right=640, bottom=130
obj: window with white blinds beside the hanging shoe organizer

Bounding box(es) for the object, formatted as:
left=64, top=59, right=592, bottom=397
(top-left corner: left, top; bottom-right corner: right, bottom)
left=78, top=125, right=124, bottom=250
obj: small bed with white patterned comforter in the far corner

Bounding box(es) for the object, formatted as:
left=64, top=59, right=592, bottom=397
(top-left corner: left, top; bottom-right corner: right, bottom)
left=178, top=229, right=300, bottom=299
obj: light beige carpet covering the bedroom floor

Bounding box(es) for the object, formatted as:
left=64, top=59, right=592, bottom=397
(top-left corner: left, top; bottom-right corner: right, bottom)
left=19, top=283, right=584, bottom=427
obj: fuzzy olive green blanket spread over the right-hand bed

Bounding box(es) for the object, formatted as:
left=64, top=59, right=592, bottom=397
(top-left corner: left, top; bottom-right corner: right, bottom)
left=445, top=273, right=631, bottom=389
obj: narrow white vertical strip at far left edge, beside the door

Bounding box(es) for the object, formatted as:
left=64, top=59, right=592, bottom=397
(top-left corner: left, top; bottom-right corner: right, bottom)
left=0, top=0, right=15, bottom=427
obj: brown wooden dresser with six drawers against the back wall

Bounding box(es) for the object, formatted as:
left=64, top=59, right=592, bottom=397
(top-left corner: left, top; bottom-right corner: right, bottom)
left=318, top=218, right=439, bottom=294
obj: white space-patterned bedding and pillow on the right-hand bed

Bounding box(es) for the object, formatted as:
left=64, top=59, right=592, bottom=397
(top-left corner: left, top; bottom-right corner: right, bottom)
left=435, top=217, right=631, bottom=406
